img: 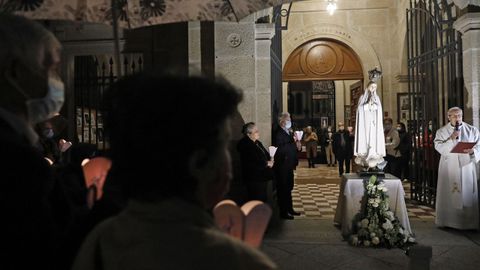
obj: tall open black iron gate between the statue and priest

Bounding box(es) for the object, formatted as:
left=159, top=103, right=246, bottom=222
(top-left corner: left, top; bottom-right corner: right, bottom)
left=406, top=0, right=463, bottom=206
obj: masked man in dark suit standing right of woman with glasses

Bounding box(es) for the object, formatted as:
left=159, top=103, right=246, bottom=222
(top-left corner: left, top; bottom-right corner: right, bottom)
left=273, top=112, right=300, bottom=219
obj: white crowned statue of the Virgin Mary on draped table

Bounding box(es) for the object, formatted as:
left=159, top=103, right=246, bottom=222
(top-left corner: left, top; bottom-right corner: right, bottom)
left=353, top=68, right=386, bottom=169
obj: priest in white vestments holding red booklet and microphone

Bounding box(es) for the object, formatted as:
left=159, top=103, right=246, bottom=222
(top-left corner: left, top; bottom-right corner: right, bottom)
left=434, top=107, right=480, bottom=230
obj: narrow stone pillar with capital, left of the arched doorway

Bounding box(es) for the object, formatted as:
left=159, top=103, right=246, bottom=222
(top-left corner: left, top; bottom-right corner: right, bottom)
left=255, top=23, right=275, bottom=145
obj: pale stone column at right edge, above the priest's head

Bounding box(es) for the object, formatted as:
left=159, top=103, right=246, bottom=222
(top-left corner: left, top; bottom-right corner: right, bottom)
left=453, top=13, right=480, bottom=128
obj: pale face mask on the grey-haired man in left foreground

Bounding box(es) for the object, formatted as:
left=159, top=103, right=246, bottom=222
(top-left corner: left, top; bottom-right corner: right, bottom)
left=26, top=78, right=65, bottom=124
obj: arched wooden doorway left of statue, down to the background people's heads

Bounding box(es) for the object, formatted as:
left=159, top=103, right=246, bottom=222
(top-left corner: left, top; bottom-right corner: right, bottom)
left=282, top=38, right=364, bottom=129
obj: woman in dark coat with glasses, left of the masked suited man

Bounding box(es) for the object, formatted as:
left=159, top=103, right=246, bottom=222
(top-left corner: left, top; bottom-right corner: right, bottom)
left=237, top=122, right=273, bottom=202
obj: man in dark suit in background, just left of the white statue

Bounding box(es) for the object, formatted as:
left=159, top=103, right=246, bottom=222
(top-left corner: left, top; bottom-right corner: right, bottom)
left=333, top=122, right=353, bottom=176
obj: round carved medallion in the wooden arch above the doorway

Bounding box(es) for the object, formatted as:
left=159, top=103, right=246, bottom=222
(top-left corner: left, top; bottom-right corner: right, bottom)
left=306, top=45, right=337, bottom=75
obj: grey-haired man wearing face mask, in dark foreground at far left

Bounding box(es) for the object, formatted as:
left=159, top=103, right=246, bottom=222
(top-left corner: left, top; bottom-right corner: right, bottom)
left=0, top=14, right=64, bottom=269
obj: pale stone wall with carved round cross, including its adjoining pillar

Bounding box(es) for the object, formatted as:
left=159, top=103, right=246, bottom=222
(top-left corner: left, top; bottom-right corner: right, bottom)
left=215, top=13, right=274, bottom=146
